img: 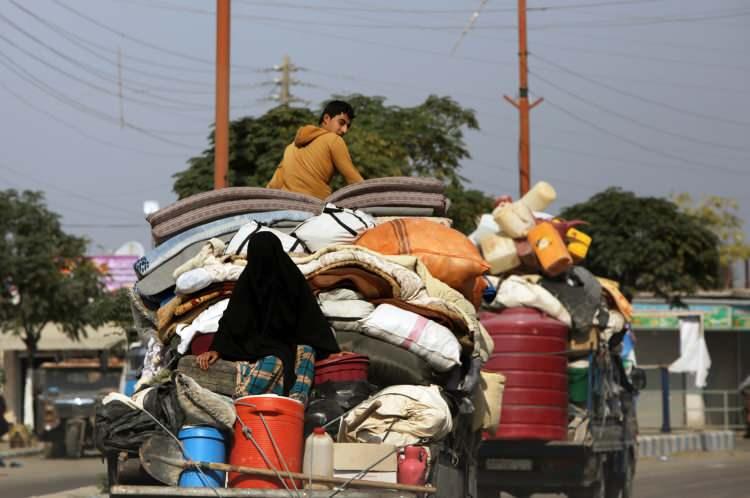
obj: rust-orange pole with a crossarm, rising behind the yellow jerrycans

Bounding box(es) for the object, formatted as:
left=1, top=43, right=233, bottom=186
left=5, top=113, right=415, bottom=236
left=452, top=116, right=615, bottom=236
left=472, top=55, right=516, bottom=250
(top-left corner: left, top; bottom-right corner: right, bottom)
left=503, top=0, right=544, bottom=196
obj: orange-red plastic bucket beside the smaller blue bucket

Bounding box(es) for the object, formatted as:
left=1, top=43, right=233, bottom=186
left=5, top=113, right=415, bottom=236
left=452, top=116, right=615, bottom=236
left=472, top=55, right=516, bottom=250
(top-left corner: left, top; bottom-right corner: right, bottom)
left=229, top=394, right=305, bottom=489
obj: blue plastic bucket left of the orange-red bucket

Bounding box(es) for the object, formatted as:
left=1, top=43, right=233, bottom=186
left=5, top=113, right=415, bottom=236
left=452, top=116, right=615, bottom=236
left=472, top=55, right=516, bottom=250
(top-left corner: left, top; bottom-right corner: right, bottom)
left=177, top=425, right=227, bottom=488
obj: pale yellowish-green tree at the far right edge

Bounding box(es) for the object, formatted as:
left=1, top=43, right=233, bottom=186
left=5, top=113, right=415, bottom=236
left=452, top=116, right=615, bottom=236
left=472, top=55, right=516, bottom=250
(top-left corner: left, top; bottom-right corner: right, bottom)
left=673, top=193, right=750, bottom=286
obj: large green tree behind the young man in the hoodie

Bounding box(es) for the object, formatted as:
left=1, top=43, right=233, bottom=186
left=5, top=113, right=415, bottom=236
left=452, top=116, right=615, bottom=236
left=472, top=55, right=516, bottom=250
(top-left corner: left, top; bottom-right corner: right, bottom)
left=174, top=94, right=491, bottom=234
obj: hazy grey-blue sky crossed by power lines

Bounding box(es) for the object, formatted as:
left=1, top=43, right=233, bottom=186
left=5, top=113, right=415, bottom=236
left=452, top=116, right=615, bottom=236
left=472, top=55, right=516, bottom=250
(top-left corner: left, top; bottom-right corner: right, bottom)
left=0, top=0, right=750, bottom=253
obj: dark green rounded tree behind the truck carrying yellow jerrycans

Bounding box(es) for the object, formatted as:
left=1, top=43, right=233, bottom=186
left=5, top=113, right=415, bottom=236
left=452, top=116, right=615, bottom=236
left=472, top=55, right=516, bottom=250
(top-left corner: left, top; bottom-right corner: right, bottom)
left=560, top=188, right=719, bottom=304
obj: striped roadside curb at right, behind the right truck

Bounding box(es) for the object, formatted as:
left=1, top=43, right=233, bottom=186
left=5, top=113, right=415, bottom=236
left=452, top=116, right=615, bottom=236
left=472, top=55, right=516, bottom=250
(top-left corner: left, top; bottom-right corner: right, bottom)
left=638, top=431, right=736, bottom=457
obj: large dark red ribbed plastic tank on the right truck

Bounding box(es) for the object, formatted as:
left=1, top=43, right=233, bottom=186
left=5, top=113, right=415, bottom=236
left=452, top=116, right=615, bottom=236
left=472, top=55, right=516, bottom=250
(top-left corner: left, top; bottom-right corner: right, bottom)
left=480, top=308, right=568, bottom=441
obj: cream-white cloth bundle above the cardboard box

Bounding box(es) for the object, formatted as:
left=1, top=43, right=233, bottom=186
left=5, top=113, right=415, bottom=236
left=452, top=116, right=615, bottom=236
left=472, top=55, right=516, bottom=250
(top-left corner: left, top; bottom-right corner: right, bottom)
left=342, top=385, right=453, bottom=446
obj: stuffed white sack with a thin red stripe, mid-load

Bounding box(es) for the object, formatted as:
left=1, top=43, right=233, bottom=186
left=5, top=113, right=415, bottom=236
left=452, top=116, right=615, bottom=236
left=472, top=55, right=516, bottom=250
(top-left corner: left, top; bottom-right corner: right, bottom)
left=361, top=304, right=461, bottom=372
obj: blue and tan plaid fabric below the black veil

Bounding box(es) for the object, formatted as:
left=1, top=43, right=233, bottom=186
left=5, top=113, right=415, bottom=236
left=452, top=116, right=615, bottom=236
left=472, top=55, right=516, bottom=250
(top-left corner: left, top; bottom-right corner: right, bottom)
left=234, top=345, right=315, bottom=404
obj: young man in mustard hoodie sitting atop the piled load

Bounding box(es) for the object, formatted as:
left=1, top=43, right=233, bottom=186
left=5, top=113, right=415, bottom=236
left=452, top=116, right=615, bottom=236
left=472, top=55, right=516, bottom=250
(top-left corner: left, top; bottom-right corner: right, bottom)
left=266, top=100, right=362, bottom=199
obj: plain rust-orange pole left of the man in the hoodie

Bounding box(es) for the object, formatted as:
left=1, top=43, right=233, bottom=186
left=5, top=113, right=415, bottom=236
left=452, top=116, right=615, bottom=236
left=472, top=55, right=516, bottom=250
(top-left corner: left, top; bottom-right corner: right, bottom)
left=214, top=0, right=231, bottom=189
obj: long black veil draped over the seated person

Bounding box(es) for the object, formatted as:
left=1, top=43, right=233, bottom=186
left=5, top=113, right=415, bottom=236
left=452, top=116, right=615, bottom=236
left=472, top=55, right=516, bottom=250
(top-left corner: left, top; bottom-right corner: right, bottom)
left=211, top=232, right=339, bottom=394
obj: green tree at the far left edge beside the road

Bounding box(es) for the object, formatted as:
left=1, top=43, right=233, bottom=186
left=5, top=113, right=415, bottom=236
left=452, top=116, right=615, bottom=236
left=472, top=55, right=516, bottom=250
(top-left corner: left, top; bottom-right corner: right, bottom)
left=0, top=190, right=103, bottom=424
